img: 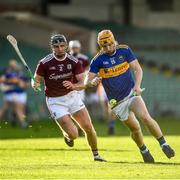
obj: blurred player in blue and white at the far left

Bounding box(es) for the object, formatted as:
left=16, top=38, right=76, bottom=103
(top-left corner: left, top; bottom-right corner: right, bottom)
left=0, top=59, right=28, bottom=128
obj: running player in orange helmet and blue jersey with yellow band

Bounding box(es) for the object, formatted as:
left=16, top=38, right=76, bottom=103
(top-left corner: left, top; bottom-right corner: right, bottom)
left=85, top=30, right=175, bottom=163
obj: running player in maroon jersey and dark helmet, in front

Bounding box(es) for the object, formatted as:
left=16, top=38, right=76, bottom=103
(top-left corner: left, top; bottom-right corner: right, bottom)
left=32, top=34, right=105, bottom=161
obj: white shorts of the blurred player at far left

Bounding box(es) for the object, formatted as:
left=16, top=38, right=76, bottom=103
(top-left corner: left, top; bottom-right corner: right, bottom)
left=4, top=92, right=27, bottom=104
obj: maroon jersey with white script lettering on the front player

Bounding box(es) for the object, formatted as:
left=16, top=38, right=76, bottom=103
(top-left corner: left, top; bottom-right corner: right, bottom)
left=36, top=54, right=83, bottom=97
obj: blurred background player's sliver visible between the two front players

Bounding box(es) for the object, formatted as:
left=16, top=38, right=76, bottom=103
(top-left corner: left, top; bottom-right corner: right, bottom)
left=97, top=83, right=115, bottom=135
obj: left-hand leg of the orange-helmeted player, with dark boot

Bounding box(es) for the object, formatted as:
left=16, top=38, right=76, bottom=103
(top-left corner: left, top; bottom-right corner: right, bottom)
left=123, top=112, right=154, bottom=163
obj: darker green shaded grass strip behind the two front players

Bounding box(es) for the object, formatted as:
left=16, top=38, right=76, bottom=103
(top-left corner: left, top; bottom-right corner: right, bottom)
left=0, top=118, right=180, bottom=139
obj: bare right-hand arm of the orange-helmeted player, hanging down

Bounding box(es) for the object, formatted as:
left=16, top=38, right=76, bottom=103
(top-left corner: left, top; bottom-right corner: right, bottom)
left=129, top=59, right=143, bottom=95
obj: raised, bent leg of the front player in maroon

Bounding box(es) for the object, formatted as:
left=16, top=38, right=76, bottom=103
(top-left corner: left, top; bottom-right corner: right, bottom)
left=56, top=114, right=78, bottom=147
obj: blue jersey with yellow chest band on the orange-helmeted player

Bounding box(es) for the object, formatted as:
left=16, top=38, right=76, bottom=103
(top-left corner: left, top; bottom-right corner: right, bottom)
left=89, top=45, right=136, bottom=101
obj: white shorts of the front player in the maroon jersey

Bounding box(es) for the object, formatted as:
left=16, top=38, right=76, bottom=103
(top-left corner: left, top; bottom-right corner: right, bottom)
left=46, top=91, right=85, bottom=120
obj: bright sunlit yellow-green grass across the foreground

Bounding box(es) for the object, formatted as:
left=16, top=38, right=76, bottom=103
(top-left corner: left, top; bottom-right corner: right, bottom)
left=0, top=136, right=180, bottom=179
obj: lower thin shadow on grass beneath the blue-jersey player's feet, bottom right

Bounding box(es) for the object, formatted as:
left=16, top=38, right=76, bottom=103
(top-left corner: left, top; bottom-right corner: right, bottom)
left=107, top=161, right=180, bottom=166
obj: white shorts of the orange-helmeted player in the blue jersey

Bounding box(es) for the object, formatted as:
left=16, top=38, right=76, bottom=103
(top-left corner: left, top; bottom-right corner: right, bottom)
left=112, top=91, right=136, bottom=121
